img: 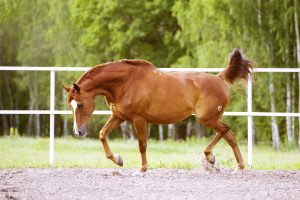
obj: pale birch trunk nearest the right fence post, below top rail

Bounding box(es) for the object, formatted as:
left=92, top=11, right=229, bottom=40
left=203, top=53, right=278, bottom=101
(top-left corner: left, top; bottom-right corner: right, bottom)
left=269, top=73, right=280, bottom=150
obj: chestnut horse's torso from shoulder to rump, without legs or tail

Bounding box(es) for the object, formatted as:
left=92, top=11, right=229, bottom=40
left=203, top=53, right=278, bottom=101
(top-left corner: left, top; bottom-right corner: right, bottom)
left=110, top=60, right=230, bottom=123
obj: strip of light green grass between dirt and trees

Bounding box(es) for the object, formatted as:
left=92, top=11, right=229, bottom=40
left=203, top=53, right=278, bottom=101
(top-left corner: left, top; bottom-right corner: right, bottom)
left=0, top=137, right=300, bottom=169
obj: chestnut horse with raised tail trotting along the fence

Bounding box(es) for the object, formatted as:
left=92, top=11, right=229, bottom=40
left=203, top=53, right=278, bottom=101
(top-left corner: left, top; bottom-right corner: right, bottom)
left=63, top=49, right=255, bottom=174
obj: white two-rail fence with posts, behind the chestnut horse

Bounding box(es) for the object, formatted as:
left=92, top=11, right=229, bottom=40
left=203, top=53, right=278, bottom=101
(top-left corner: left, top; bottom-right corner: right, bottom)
left=0, top=66, right=300, bottom=167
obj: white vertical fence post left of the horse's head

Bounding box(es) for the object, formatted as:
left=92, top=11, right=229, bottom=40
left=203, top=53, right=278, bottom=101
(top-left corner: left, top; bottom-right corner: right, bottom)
left=49, top=70, right=55, bottom=165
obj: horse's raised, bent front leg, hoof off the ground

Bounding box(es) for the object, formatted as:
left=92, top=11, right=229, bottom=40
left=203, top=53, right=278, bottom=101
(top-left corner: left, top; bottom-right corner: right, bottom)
left=99, top=114, right=124, bottom=166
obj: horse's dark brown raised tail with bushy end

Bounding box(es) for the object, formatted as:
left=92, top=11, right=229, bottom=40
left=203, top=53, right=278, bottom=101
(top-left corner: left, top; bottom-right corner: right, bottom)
left=219, top=49, right=255, bottom=84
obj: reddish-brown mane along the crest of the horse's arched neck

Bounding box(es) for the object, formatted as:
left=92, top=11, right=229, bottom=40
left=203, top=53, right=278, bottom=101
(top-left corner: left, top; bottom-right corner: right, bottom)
left=76, top=59, right=155, bottom=84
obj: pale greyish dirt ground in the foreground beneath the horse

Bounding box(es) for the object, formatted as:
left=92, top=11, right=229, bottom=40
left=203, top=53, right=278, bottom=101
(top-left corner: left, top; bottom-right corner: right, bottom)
left=0, top=169, right=300, bottom=200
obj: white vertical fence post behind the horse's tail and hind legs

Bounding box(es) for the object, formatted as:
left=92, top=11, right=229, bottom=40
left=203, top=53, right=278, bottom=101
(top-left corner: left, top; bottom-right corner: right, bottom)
left=247, top=75, right=253, bottom=168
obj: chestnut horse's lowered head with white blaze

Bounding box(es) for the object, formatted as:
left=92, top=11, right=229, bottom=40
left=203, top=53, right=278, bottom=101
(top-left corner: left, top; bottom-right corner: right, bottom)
left=63, top=83, right=95, bottom=137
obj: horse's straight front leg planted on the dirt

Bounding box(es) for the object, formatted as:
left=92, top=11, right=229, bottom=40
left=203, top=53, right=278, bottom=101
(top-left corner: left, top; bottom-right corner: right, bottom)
left=133, top=118, right=148, bottom=173
